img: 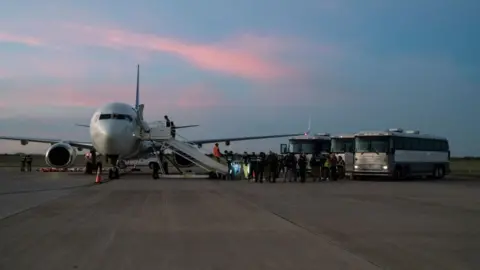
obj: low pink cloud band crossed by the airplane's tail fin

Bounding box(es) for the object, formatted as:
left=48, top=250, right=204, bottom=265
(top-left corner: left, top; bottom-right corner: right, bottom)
left=0, top=81, right=232, bottom=113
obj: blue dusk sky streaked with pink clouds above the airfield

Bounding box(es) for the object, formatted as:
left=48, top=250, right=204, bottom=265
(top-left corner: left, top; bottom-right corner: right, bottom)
left=0, top=0, right=480, bottom=156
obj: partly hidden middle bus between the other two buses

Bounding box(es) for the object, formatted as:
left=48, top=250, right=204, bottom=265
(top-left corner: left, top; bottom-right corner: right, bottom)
left=330, top=134, right=355, bottom=176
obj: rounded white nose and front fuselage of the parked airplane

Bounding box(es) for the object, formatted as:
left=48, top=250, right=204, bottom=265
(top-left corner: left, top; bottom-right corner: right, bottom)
left=90, top=103, right=144, bottom=159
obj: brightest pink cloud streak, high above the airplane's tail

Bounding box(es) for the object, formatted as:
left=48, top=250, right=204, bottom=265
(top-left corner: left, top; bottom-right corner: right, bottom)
left=42, top=24, right=296, bottom=80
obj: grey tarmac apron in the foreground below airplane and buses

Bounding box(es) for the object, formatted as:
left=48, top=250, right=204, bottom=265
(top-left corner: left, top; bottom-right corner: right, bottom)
left=0, top=171, right=480, bottom=270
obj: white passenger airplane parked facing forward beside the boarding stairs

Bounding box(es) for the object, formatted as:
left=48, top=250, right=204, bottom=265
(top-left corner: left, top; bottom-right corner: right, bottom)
left=0, top=65, right=303, bottom=179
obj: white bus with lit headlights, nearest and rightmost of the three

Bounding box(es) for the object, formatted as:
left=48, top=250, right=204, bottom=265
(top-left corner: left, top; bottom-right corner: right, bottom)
left=352, top=129, right=450, bottom=179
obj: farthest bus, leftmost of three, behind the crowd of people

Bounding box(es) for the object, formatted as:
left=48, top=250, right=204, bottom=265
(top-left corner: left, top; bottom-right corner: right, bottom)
left=280, top=133, right=331, bottom=171
